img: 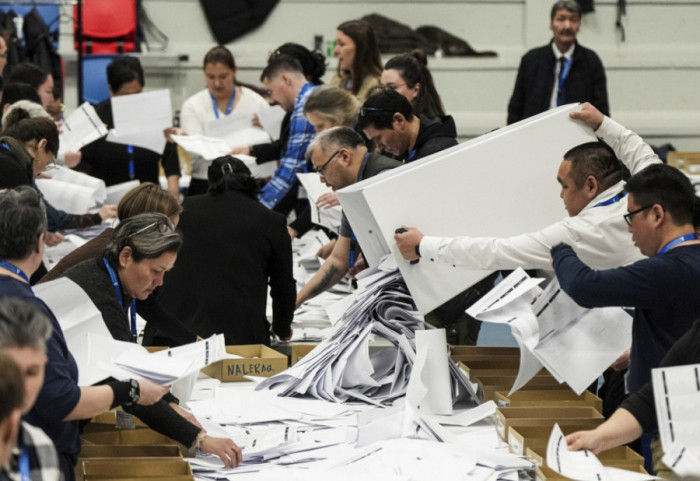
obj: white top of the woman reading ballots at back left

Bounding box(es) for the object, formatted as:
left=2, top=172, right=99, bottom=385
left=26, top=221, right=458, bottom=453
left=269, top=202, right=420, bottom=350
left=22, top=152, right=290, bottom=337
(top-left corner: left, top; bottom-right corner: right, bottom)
left=180, top=87, right=270, bottom=180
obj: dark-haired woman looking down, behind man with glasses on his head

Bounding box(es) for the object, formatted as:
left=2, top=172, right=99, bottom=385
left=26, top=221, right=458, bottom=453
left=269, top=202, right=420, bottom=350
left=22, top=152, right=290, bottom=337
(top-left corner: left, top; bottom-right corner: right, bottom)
left=381, top=49, right=446, bottom=118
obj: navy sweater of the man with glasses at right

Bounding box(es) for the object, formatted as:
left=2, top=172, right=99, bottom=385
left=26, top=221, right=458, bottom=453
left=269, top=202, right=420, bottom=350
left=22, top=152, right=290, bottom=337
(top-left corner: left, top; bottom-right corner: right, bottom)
left=552, top=244, right=700, bottom=393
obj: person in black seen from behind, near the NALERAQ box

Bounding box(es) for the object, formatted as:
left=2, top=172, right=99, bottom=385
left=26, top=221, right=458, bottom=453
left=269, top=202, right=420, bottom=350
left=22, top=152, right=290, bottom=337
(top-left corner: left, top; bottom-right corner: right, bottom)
left=146, top=156, right=296, bottom=345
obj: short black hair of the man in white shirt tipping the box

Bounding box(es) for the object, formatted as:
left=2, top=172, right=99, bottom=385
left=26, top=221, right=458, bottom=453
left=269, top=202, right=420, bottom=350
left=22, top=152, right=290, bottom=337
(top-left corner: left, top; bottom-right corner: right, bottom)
left=564, top=140, right=622, bottom=192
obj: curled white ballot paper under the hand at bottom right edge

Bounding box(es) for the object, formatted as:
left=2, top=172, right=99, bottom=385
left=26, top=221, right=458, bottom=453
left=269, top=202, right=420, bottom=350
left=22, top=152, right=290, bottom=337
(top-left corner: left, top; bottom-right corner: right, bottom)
left=547, top=424, right=659, bottom=481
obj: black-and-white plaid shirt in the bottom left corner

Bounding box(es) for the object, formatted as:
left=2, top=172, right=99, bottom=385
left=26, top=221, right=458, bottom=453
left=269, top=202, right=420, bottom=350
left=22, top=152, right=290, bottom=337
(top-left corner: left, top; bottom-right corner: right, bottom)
left=2, top=421, right=63, bottom=481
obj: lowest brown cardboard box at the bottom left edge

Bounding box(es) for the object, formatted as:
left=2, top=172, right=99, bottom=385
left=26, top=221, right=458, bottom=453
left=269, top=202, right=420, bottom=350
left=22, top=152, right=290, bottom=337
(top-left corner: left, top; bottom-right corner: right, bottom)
left=82, top=459, right=192, bottom=481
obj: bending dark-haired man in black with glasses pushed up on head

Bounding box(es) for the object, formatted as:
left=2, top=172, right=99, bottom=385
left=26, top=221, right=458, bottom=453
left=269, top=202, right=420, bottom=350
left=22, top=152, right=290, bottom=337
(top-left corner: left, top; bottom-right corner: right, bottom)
left=357, top=89, right=457, bottom=163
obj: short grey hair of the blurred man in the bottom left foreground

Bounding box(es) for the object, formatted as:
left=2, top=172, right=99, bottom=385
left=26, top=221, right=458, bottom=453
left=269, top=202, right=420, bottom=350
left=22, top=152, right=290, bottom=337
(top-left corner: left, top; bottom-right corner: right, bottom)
left=0, top=297, right=53, bottom=350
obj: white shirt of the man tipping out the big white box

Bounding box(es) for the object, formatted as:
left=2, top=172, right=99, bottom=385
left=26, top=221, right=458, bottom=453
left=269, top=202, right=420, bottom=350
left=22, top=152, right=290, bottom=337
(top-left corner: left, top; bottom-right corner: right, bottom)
left=420, top=117, right=661, bottom=271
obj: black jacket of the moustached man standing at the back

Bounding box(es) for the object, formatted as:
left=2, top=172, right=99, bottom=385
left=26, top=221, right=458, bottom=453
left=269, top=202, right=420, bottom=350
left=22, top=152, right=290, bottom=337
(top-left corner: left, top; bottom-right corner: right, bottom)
left=508, top=42, right=610, bottom=124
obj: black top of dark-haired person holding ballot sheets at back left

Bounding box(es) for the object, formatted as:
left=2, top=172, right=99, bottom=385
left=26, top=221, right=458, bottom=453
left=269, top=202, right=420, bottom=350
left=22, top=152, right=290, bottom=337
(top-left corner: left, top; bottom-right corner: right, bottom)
left=76, top=99, right=180, bottom=185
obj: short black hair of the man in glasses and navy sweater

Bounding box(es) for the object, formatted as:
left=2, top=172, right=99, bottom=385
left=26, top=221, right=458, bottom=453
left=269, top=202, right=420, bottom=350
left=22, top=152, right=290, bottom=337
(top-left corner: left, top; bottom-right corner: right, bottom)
left=625, top=164, right=695, bottom=225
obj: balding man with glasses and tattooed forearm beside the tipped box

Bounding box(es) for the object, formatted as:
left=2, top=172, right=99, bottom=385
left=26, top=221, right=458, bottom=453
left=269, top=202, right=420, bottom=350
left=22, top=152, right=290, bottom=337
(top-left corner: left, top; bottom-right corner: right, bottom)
left=296, top=127, right=401, bottom=307
